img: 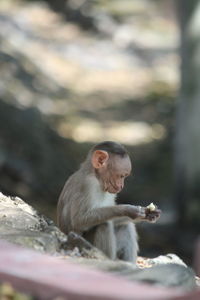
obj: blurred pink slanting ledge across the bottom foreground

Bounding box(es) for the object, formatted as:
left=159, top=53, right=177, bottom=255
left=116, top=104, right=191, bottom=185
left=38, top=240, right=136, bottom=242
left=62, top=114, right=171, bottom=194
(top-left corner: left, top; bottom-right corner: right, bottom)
left=0, top=241, right=197, bottom=300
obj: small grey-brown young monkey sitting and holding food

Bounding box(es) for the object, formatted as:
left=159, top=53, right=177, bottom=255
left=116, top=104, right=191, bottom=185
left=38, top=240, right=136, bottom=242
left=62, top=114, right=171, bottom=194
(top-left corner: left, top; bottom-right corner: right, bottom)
left=57, top=141, right=161, bottom=264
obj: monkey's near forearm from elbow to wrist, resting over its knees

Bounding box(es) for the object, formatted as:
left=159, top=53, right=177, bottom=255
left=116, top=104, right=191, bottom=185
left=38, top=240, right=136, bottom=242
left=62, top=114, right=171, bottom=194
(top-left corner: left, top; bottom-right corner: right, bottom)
left=72, top=205, right=145, bottom=232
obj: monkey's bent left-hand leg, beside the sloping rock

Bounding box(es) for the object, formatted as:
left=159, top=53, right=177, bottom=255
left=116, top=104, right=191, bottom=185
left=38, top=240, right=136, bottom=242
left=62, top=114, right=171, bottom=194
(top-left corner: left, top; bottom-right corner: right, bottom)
left=83, top=221, right=116, bottom=260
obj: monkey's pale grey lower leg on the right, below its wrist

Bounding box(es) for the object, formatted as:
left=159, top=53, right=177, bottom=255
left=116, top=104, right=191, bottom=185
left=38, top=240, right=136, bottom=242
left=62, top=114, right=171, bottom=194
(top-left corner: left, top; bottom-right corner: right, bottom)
left=115, top=222, right=139, bottom=264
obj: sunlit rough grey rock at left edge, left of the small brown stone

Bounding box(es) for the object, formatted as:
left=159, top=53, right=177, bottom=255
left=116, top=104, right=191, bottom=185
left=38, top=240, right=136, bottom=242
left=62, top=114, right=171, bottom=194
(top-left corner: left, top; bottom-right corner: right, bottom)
left=0, top=193, right=61, bottom=253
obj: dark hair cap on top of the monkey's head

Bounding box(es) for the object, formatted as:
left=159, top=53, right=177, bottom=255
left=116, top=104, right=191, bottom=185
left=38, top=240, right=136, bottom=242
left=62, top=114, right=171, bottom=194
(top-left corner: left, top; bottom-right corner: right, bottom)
left=92, top=141, right=128, bottom=157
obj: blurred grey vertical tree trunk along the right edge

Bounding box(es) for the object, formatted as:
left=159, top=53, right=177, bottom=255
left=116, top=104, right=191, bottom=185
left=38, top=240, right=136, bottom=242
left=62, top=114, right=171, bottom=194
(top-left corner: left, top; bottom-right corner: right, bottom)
left=175, top=0, right=200, bottom=228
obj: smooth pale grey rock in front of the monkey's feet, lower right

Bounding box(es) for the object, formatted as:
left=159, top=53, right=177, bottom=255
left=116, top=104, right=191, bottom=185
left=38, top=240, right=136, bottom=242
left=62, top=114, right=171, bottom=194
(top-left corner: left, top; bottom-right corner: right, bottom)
left=67, top=257, right=198, bottom=290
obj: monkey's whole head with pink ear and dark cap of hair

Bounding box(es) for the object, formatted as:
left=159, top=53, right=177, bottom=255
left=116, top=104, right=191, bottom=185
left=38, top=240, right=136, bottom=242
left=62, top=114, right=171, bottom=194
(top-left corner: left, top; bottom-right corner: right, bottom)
left=91, top=141, right=131, bottom=194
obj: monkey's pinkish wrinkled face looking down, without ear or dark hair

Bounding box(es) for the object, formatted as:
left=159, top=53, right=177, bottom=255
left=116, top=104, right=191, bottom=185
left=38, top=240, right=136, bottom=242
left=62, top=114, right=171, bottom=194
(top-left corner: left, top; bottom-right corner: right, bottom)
left=95, top=154, right=131, bottom=194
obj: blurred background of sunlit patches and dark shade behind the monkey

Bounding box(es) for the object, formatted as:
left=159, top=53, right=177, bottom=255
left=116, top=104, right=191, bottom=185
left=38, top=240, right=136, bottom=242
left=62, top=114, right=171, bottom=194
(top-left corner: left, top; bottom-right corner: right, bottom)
left=0, top=0, right=200, bottom=264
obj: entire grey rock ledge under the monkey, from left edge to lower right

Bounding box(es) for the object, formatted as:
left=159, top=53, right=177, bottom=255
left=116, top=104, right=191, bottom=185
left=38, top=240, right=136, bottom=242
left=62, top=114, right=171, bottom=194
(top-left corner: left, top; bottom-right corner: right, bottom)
left=0, top=193, right=196, bottom=290
